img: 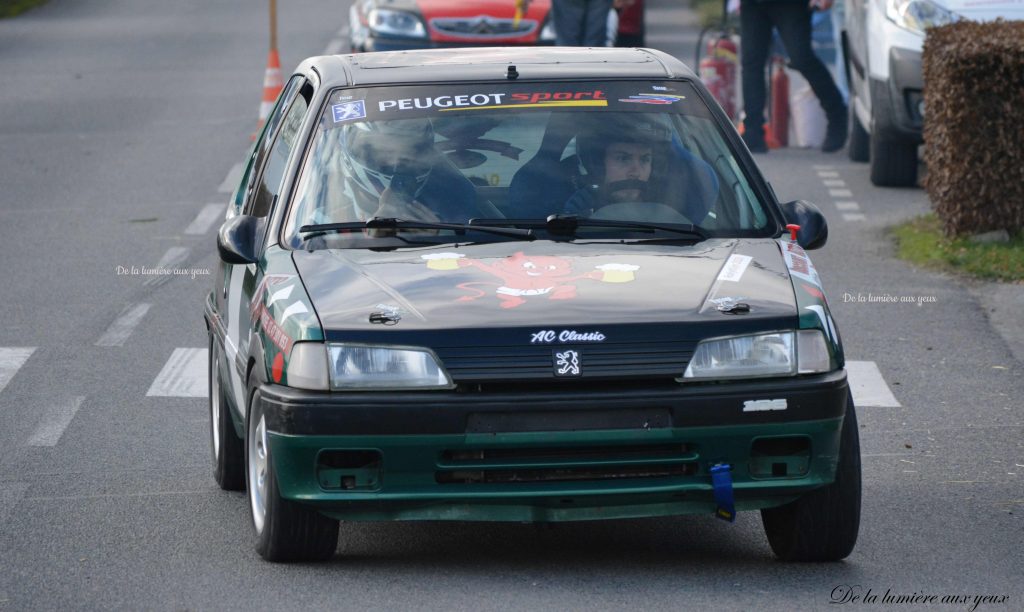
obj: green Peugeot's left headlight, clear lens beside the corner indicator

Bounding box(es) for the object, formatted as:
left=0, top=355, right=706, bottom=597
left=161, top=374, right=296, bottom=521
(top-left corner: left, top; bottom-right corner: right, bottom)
left=328, top=344, right=455, bottom=390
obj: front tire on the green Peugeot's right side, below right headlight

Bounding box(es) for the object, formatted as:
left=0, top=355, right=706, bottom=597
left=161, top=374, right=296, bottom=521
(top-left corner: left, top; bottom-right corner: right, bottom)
left=761, top=396, right=860, bottom=561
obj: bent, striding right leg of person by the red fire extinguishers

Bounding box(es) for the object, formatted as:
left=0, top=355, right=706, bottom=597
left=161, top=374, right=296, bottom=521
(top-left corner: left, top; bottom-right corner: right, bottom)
left=774, top=2, right=847, bottom=152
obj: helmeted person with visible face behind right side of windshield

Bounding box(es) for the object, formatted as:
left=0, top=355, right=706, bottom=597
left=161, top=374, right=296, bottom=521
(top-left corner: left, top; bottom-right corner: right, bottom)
left=563, top=114, right=672, bottom=217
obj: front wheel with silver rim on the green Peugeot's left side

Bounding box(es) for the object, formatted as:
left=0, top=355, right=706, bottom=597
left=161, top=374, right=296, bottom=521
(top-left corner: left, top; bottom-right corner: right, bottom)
left=245, top=389, right=338, bottom=562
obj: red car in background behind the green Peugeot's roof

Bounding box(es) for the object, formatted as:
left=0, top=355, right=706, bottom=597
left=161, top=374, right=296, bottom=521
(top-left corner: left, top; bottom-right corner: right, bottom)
left=348, top=0, right=555, bottom=52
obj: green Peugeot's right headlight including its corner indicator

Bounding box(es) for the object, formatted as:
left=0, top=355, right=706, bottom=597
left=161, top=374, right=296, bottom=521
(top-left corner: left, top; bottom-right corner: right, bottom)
left=679, top=330, right=831, bottom=382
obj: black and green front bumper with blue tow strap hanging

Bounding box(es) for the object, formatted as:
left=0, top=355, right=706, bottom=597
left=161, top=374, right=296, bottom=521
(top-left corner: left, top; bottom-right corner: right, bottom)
left=260, top=370, right=848, bottom=521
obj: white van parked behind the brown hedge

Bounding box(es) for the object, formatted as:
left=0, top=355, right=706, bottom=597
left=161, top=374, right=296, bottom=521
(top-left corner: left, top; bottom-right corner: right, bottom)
left=843, top=0, right=1024, bottom=186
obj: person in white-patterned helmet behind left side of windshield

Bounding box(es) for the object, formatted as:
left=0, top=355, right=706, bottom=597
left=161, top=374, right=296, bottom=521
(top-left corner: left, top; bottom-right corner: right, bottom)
left=342, top=119, right=476, bottom=222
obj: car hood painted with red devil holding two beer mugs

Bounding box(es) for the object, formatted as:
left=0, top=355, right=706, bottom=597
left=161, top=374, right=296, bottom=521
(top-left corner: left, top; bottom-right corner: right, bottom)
left=293, top=238, right=797, bottom=339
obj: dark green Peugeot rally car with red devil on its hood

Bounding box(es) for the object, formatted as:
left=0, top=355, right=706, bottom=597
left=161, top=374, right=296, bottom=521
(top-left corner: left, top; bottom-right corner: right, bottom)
left=205, top=47, right=860, bottom=561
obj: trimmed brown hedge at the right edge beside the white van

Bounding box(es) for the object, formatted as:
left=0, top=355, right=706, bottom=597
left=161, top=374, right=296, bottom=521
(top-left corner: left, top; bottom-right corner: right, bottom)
left=922, top=19, right=1024, bottom=236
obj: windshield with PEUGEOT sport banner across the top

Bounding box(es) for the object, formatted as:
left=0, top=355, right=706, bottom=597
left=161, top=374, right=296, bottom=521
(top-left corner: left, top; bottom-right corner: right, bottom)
left=282, top=81, right=775, bottom=248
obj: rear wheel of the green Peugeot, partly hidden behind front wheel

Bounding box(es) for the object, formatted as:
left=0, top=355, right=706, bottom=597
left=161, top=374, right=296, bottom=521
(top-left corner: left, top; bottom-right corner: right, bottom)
left=207, top=336, right=246, bottom=491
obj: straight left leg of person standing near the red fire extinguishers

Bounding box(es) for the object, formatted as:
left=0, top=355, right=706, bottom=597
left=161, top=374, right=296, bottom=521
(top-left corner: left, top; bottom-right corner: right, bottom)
left=739, top=1, right=776, bottom=152
